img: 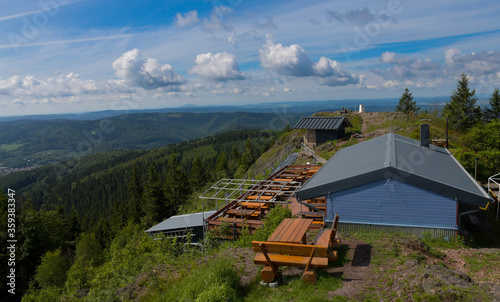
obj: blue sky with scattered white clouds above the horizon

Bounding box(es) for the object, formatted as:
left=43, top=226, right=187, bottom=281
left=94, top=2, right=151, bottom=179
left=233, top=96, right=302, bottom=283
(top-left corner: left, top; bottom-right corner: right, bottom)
left=0, top=0, right=500, bottom=116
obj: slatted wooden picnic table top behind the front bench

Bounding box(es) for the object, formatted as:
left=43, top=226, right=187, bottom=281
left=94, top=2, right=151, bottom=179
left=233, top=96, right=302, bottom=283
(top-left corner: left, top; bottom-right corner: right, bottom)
left=267, top=218, right=313, bottom=244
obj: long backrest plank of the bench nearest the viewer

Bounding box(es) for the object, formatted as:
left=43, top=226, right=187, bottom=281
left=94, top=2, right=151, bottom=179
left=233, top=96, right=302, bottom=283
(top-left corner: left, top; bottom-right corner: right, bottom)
left=252, top=241, right=328, bottom=257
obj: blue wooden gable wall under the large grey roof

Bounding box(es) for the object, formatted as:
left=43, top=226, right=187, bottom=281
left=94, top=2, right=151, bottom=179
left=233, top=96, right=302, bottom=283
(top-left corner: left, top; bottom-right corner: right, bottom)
left=326, top=179, right=457, bottom=229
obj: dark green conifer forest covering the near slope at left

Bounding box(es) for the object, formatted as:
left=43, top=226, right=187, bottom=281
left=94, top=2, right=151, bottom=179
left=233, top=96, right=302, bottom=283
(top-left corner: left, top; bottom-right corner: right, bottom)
left=0, top=130, right=283, bottom=297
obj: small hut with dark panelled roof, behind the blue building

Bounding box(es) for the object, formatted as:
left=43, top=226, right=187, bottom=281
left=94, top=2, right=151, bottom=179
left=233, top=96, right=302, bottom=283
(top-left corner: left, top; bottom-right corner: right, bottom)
left=294, top=116, right=352, bottom=149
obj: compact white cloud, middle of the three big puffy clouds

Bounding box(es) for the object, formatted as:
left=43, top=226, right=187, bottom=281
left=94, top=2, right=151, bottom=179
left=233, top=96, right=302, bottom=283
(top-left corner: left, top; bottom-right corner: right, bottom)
left=189, top=52, right=244, bottom=82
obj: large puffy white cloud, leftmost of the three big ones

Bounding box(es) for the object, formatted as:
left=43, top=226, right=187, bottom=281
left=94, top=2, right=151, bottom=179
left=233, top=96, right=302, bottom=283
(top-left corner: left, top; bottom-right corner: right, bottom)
left=113, top=49, right=184, bottom=90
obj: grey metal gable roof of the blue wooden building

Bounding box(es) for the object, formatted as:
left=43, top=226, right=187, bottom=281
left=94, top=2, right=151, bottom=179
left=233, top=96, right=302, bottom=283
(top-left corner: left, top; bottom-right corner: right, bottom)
left=295, top=133, right=493, bottom=207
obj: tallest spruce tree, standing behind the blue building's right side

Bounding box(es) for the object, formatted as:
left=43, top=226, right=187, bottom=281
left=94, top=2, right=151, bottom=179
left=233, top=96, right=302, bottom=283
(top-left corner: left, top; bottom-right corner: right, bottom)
left=443, top=73, right=481, bottom=132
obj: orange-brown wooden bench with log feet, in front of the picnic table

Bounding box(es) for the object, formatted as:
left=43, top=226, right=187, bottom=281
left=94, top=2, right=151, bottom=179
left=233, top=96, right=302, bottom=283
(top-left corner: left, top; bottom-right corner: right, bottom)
left=252, top=241, right=328, bottom=283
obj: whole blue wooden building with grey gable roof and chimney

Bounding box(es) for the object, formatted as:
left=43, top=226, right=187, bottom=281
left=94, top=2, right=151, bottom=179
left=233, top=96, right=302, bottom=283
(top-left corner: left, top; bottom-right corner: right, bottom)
left=296, top=125, right=493, bottom=238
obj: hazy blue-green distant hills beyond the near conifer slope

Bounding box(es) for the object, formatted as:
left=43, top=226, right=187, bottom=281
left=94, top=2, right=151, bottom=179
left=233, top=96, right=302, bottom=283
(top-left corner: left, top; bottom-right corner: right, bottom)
left=0, top=112, right=299, bottom=168
